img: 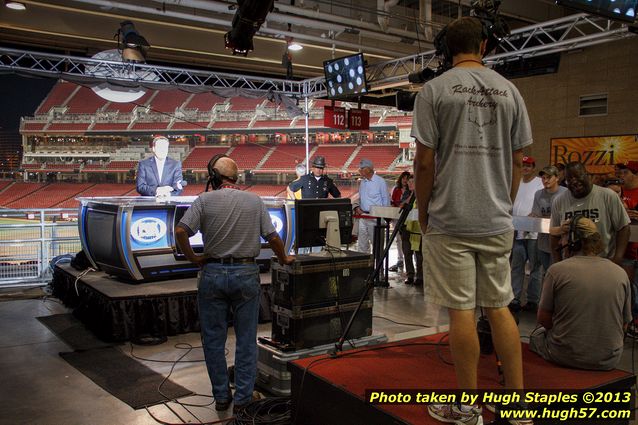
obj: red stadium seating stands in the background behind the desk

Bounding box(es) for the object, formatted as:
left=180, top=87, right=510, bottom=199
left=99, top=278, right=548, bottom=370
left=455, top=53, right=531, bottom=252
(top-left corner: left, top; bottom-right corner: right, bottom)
left=10, top=82, right=412, bottom=208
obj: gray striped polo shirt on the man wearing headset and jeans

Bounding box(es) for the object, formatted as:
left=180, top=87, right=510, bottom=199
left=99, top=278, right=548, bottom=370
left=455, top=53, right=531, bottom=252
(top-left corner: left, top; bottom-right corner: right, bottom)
left=179, top=188, right=275, bottom=258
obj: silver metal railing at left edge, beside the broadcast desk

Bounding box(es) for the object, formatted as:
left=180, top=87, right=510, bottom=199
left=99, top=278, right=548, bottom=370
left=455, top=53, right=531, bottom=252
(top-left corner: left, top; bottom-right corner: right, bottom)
left=0, top=208, right=82, bottom=288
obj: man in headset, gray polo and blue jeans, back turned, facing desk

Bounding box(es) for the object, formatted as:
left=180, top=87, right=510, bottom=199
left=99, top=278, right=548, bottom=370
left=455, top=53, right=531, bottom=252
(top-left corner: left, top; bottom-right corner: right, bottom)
left=175, top=155, right=294, bottom=412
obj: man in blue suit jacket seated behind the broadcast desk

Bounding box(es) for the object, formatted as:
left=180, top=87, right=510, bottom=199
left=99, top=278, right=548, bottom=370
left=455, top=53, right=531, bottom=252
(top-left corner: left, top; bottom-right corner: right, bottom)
left=136, top=136, right=183, bottom=196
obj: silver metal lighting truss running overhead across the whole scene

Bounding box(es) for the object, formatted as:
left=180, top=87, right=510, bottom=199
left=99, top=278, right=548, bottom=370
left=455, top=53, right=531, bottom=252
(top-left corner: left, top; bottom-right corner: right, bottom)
left=0, top=13, right=634, bottom=97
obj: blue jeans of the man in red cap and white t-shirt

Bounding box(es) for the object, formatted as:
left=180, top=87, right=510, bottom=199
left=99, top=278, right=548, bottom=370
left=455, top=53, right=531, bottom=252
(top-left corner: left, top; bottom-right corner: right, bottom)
left=512, top=239, right=541, bottom=304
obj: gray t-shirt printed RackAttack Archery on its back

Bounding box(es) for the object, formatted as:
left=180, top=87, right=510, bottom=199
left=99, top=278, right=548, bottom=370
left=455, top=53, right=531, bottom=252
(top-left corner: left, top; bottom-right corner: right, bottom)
left=411, top=68, right=532, bottom=236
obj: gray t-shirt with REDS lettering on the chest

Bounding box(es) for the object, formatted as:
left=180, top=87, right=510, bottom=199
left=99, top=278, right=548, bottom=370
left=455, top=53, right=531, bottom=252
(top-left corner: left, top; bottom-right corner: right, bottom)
left=551, top=185, right=630, bottom=258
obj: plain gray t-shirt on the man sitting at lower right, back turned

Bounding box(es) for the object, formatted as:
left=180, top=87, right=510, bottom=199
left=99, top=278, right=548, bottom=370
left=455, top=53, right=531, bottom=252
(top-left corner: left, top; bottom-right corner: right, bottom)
left=539, top=255, right=631, bottom=369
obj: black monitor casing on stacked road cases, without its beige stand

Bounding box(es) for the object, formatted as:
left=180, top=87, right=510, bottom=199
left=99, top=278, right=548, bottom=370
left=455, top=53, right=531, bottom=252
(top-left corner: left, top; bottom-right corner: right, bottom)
left=295, top=199, right=352, bottom=248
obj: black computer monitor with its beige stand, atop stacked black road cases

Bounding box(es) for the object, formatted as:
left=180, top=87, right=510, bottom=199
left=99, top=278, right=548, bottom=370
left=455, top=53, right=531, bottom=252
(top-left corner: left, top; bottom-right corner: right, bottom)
left=295, top=199, right=352, bottom=252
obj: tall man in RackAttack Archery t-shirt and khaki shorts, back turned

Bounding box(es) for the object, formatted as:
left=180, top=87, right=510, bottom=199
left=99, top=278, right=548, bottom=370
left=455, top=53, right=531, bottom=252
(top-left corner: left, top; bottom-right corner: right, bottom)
left=411, top=17, right=532, bottom=425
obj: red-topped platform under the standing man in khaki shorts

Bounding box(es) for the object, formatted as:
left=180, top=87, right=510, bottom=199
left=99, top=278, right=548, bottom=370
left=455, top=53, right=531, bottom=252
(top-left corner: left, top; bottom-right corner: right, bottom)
left=288, top=334, right=636, bottom=425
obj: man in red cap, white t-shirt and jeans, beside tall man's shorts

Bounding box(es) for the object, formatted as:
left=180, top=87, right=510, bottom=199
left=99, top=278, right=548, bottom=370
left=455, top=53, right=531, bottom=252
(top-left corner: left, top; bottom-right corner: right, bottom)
left=510, top=156, right=543, bottom=312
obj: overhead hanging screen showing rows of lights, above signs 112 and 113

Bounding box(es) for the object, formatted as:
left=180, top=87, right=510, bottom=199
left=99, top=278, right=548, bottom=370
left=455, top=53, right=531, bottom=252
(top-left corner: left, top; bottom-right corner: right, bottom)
left=323, top=53, right=368, bottom=99
